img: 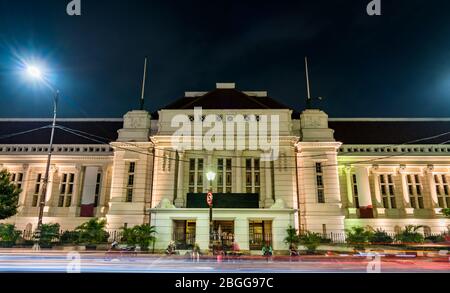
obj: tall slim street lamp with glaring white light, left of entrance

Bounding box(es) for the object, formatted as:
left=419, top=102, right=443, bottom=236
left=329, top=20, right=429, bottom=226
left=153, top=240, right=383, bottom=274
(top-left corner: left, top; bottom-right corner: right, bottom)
left=27, top=66, right=59, bottom=250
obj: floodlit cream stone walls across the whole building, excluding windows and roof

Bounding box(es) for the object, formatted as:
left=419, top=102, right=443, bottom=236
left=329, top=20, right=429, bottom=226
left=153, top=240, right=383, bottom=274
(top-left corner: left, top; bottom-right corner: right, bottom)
left=0, top=109, right=450, bottom=250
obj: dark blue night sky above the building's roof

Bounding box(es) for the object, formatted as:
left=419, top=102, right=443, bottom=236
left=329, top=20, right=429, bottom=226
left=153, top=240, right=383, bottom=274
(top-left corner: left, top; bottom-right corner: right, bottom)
left=0, top=0, right=450, bottom=118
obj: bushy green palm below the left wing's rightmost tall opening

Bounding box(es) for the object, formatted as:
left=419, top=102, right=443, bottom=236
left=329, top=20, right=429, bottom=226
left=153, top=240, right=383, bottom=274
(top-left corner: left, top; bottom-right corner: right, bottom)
left=75, top=218, right=109, bottom=250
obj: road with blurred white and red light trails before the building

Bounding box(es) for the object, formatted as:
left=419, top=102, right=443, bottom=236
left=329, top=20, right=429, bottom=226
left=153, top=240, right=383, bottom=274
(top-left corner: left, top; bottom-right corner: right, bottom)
left=0, top=252, right=450, bottom=273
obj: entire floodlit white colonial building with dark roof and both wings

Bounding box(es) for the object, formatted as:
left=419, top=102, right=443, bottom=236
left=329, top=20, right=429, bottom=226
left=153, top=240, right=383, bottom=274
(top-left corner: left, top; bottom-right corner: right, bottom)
left=0, top=84, right=450, bottom=250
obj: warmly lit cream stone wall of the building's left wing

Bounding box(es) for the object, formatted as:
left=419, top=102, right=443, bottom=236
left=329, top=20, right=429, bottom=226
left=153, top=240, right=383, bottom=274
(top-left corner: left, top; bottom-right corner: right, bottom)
left=0, top=151, right=113, bottom=230
